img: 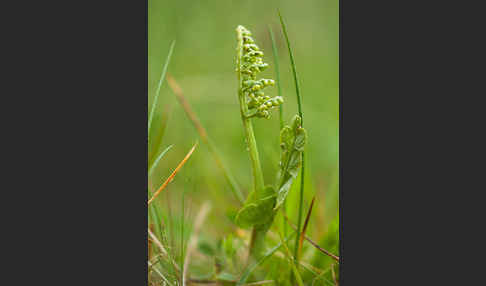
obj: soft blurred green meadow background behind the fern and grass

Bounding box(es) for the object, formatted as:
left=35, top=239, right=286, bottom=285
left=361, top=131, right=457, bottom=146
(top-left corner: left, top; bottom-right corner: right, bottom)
left=148, top=0, right=339, bottom=266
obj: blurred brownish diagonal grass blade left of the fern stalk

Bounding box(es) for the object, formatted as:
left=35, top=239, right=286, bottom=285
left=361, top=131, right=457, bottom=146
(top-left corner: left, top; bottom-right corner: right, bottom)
left=167, top=74, right=245, bottom=204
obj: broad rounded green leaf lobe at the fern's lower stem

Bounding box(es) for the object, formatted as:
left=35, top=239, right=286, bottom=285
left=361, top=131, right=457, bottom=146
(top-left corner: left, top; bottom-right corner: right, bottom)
left=236, top=186, right=275, bottom=228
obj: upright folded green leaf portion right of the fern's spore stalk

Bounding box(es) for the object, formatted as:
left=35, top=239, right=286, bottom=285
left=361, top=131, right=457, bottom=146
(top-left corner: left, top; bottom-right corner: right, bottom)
left=274, top=115, right=307, bottom=209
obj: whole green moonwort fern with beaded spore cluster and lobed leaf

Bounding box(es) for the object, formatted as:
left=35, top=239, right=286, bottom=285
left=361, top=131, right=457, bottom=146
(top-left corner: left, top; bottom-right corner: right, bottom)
left=235, top=25, right=307, bottom=261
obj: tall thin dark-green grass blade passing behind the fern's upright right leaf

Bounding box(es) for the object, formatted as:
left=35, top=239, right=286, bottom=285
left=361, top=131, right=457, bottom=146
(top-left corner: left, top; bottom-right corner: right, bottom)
left=278, top=11, right=305, bottom=265
